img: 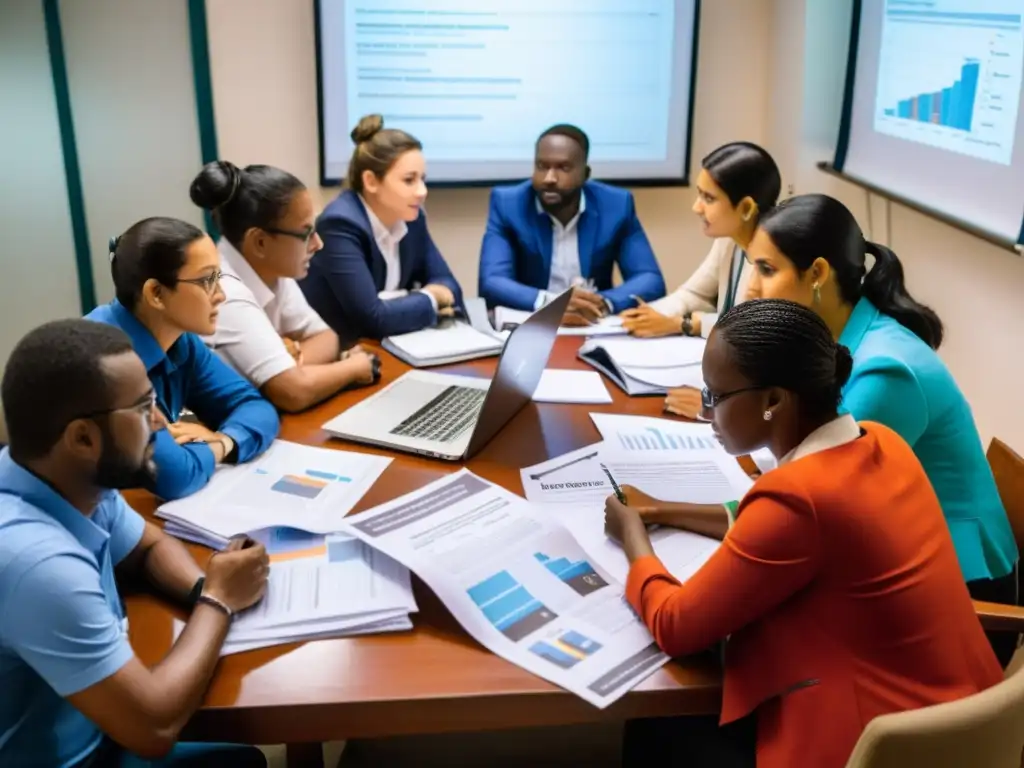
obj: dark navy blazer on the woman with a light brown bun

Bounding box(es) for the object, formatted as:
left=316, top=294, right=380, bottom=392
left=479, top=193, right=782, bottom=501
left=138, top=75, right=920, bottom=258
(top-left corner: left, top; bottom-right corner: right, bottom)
left=299, top=189, right=462, bottom=341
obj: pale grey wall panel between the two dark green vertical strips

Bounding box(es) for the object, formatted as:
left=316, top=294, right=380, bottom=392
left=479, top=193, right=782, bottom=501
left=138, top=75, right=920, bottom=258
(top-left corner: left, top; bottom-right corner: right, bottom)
left=59, top=0, right=203, bottom=303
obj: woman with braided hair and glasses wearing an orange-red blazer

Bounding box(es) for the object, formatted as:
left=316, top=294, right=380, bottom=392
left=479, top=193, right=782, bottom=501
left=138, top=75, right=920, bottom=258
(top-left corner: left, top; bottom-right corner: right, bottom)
left=605, top=300, right=1002, bottom=768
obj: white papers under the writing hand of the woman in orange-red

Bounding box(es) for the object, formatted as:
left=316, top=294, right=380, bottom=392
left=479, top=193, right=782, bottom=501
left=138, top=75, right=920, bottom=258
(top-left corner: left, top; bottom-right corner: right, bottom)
left=520, top=442, right=752, bottom=582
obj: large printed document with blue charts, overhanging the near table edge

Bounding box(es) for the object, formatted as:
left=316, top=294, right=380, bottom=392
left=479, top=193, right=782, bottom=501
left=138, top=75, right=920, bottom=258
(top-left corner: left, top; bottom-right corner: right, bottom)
left=345, top=470, right=668, bottom=708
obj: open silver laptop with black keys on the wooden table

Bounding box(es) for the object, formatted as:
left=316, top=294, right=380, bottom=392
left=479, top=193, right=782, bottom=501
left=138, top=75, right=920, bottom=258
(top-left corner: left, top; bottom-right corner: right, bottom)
left=324, top=290, right=572, bottom=461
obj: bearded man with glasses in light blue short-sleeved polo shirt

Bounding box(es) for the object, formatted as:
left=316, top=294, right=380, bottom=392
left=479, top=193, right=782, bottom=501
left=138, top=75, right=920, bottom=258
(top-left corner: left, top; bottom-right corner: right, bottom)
left=0, top=319, right=269, bottom=768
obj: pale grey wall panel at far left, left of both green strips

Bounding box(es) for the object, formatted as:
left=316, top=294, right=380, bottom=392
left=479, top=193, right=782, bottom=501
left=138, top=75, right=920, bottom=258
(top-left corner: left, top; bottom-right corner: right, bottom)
left=0, top=2, right=81, bottom=436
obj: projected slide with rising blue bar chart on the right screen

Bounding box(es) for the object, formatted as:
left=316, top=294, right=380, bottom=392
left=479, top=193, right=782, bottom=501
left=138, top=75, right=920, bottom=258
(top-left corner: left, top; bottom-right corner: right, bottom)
left=874, top=0, right=1024, bottom=165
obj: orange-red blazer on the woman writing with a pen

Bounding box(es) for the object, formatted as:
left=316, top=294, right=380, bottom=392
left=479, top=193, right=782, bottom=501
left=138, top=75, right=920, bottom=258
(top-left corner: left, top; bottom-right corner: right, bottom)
left=627, top=423, right=1002, bottom=768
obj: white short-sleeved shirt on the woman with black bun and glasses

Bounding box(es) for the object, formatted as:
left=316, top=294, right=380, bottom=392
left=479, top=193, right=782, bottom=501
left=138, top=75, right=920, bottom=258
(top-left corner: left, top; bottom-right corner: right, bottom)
left=203, top=239, right=330, bottom=387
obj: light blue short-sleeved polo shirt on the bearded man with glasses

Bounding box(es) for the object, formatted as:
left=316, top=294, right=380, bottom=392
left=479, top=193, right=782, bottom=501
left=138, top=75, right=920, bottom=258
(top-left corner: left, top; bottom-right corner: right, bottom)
left=0, top=449, right=144, bottom=768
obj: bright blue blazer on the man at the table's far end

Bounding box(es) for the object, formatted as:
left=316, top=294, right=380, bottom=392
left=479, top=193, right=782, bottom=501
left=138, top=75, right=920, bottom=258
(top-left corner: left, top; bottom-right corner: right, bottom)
left=479, top=181, right=665, bottom=312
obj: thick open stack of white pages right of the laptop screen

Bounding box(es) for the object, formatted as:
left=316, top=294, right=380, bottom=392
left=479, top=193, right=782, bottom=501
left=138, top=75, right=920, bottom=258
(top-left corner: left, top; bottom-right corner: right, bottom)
left=579, top=336, right=706, bottom=395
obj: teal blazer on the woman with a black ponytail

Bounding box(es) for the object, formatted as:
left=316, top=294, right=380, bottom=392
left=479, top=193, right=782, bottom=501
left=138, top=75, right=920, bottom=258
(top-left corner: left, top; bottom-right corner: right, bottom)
left=839, top=298, right=1018, bottom=582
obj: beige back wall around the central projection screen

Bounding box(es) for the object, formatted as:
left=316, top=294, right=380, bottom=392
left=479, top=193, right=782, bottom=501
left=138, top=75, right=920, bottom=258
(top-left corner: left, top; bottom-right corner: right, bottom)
left=207, top=0, right=772, bottom=294
